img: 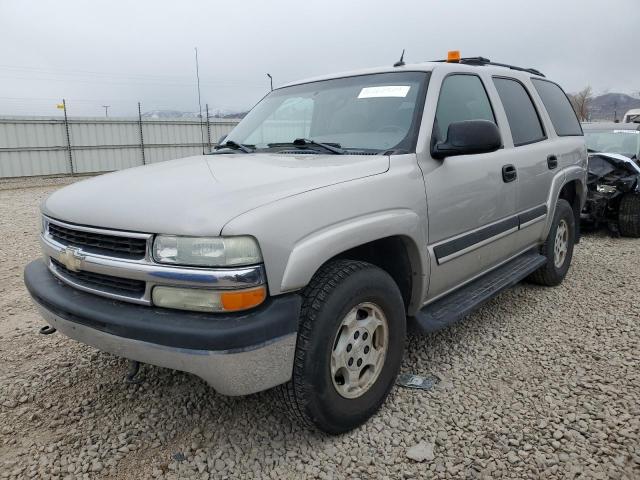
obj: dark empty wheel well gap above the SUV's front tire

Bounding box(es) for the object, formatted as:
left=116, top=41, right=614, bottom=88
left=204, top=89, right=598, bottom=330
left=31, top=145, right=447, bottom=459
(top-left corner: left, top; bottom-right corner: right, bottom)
left=332, top=236, right=413, bottom=309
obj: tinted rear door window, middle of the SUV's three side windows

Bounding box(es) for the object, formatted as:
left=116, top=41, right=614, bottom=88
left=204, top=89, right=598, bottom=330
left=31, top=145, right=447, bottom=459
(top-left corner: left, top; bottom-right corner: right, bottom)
left=493, top=78, right=545, bottom=146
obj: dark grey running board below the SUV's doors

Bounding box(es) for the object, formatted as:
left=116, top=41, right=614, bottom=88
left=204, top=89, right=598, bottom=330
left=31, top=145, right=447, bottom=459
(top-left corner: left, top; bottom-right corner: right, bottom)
left=411, top=249, right=547, bottom=333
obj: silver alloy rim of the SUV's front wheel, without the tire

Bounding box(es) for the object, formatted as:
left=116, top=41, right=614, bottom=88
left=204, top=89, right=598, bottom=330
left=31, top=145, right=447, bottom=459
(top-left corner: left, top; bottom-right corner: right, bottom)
left=331, top=302, right=389, bottom=398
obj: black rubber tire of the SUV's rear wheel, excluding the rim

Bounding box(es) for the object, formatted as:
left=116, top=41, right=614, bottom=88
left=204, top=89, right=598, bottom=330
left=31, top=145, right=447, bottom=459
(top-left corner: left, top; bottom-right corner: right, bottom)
left=527, top=199, right=576, bottom=287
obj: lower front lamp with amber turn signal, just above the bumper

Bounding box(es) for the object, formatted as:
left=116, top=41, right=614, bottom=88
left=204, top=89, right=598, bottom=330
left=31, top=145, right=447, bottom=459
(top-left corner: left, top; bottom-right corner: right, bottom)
left=152, top=286, right=267, bottom=312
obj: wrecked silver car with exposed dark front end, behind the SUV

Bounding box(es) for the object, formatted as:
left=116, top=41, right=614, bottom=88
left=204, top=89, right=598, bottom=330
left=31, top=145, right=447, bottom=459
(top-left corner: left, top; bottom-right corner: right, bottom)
left=581, top=123, right=640, bottom=237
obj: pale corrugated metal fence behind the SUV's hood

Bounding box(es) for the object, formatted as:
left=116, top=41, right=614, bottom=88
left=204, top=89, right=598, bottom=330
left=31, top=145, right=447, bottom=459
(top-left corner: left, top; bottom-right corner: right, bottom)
left=0, top=117, right=239, bottom=177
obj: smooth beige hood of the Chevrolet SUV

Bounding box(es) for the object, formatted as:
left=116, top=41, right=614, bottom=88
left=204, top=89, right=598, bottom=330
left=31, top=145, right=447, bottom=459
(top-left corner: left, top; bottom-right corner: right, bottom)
left=42, top=153, right=389, bottom=235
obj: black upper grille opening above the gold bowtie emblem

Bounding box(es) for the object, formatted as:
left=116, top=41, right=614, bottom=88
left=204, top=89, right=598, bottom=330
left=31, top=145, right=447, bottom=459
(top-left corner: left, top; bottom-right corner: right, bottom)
left=48, top=222, right=147, bottom=260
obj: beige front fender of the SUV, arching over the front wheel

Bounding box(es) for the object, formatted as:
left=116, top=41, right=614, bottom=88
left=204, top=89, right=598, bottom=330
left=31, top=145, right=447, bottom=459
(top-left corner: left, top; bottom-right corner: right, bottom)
left=221, top=155, right=429, bottom=310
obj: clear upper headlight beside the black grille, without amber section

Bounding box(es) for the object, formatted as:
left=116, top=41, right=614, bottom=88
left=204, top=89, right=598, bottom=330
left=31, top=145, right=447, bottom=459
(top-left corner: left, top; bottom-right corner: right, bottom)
left=153, top=235, right=262, bottom=267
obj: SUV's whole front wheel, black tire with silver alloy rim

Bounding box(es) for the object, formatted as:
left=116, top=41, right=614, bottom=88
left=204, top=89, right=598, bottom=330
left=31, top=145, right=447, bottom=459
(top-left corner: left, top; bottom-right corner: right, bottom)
left=279, top=260, right=406, bottom=434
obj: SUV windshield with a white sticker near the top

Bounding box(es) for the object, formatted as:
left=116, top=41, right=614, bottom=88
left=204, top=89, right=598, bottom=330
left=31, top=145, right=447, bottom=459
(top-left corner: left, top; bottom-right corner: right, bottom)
left=227, top=72, right=429, bottom=153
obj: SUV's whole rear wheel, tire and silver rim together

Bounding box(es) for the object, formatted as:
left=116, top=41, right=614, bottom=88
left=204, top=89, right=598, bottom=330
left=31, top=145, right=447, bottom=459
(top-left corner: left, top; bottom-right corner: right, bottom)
left=528, top=199, right=576, bottom=287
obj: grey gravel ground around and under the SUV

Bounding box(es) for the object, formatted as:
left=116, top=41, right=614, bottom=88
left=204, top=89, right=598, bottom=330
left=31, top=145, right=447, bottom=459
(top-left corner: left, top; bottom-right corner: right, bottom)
left=0, top=179, right=640, bottom=479
